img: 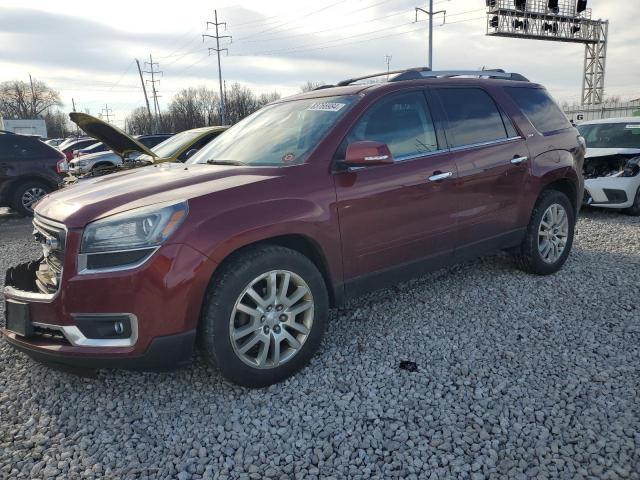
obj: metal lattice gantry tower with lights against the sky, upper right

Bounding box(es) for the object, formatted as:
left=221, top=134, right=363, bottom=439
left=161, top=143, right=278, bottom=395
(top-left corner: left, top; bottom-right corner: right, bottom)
left=486, top=0, right=609, bottom=105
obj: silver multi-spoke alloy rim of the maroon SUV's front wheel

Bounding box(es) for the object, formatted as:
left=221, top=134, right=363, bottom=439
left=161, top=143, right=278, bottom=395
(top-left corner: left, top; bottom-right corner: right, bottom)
left=229, top=270, right=314, bottom=369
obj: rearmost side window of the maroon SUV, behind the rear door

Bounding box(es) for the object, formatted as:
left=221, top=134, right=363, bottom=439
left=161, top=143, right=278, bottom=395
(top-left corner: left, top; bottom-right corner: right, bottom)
left=505, top=87, right=571, bottom=134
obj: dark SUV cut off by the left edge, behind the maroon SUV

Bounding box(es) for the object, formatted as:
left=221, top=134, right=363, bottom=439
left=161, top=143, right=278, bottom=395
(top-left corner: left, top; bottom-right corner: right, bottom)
left=0, top=132, right=66, bottom=216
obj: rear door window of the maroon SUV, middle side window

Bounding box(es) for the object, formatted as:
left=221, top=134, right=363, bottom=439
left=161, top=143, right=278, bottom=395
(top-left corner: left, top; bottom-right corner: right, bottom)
left=435, top=88, right=514, bottom=148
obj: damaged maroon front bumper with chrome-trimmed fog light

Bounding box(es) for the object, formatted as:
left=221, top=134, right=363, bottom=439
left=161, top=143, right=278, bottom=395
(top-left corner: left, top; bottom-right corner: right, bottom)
left=2, top=223, right=214, bottom=369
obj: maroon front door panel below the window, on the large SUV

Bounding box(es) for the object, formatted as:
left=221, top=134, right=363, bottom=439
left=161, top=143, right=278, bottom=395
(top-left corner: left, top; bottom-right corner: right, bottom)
left=335, top=153, right=458, bottom=279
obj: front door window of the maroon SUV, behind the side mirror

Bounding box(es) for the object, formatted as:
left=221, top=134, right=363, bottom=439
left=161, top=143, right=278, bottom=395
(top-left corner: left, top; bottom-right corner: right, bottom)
left=338, top=92, right=438, bottom=160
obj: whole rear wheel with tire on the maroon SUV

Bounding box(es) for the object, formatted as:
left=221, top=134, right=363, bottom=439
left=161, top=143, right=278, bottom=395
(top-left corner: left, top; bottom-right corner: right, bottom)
left=514, top=190, right=576, bottom=275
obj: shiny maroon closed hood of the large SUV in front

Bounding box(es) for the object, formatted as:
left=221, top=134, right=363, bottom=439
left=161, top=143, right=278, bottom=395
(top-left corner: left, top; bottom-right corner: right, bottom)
left=36, top=163, right=275, bottom=228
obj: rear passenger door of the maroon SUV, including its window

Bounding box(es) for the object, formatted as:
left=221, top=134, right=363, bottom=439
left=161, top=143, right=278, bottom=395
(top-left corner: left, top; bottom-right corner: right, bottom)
left=433, top=86, right=529, bottom=248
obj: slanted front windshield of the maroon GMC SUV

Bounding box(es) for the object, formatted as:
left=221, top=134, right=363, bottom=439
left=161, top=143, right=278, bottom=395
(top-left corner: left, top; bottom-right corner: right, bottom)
left=187, top=96, right=359, bottom=166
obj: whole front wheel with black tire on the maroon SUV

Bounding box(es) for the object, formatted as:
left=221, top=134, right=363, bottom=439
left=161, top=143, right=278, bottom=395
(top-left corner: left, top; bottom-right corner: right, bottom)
left=200, top=245, right=329, bottom=388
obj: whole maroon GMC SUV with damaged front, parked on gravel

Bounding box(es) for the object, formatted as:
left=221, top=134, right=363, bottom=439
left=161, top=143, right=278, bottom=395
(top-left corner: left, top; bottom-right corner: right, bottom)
left=3, top=69, right=585, bottom=387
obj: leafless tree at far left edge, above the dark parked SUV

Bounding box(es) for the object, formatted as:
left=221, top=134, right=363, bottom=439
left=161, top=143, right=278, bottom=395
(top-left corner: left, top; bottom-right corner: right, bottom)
left=0, top=79, right=62, bottom=119
